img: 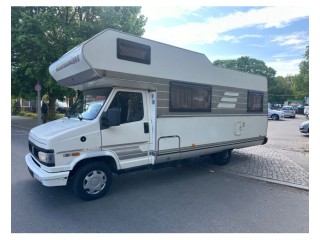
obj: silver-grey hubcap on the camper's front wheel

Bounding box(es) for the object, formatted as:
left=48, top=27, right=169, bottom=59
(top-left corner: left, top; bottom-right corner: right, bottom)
left=83, top=170, right=107, bottom=194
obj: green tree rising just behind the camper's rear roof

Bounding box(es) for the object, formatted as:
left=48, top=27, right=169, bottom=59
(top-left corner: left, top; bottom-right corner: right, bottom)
left=213, top=56, right=278, bottom=102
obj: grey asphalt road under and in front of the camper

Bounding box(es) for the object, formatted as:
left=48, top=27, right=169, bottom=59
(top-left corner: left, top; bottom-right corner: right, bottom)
left=11, top=124, right=309, bottom=232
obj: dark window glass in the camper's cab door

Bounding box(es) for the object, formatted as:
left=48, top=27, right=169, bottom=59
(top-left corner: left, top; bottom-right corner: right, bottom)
left=109, top=92, right=144, bottom=124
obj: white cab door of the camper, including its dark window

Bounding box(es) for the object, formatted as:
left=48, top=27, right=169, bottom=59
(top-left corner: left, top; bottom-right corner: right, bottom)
left=101, top=89, right=150, bottom=169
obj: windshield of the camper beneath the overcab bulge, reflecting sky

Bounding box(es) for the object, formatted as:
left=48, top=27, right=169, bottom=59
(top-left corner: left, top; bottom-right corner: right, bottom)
left=68, top=88, right=112, bottom=120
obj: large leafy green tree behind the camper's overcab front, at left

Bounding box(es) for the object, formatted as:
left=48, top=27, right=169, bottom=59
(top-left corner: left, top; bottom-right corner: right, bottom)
left=11, top=7, right=147, bottom=116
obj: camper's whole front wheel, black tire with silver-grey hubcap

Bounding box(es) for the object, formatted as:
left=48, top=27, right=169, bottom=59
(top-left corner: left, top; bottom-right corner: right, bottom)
left=72, top=162, right=112, bottom=201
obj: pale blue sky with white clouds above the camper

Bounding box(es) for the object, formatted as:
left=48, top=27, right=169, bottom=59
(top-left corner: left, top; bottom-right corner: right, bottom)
left=141, top=5, right=309, bottom=77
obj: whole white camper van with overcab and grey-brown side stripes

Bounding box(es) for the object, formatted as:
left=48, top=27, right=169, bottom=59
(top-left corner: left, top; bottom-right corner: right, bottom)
left=25, top=29, right=268, bottom=200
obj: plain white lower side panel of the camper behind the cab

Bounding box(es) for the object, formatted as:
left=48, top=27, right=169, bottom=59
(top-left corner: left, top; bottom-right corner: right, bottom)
left=155, top=116, right=267, bottom=163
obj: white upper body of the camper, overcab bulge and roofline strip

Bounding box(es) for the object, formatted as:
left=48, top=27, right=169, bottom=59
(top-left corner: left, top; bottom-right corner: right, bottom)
left=49, top=29, right=267, bottom=90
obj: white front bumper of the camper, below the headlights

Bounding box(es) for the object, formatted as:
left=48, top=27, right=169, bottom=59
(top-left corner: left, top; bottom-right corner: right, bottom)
left=25, top=153, right=70, bottom=187
